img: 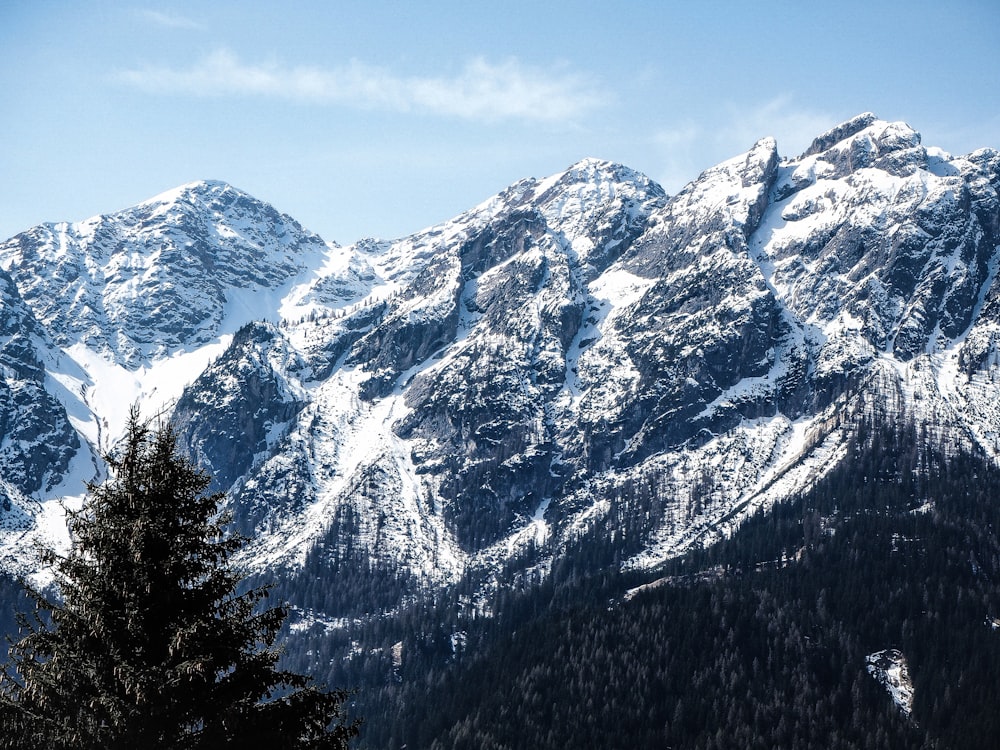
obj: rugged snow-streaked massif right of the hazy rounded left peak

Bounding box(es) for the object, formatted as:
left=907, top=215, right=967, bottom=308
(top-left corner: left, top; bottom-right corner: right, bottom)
left=168, top=115, right=1000, bottom=588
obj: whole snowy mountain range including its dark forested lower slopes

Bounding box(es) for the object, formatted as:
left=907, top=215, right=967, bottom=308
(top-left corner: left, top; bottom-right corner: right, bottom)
left=0, top=114, right=1000, bottom=750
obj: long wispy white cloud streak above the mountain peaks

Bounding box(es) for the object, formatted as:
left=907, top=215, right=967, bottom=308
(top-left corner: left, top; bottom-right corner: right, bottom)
left=119, top=51, right=608, bottom=122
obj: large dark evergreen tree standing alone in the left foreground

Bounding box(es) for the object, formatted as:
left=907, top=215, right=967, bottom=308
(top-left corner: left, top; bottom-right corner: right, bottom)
left=0, top=409, right=357, bottom=750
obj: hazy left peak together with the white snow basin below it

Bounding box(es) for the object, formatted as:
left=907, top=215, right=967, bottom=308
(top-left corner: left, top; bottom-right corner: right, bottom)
left=0, top=182, right=336, bottom=558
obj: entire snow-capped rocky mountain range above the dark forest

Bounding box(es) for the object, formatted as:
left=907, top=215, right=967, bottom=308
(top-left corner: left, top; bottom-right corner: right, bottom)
left=0, top=114, right=1000, bottom=614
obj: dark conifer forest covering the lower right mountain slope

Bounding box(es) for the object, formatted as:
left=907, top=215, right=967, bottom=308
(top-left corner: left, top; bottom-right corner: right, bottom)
left=335, top=427, right=1000, bottom=750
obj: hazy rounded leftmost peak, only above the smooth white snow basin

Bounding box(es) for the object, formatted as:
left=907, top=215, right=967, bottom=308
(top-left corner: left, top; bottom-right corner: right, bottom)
left=0, top=182, right=330, bottom=370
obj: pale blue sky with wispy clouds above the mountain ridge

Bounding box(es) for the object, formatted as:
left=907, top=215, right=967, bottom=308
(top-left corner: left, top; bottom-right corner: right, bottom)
left=0, top=0, right=1000, bottom=243
